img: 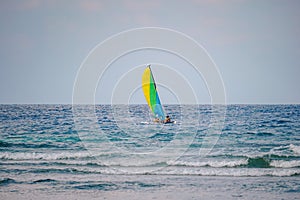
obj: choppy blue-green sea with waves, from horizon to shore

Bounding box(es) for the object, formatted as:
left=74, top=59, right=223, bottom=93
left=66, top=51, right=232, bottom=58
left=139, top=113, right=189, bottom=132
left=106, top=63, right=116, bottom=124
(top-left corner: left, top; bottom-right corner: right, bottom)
left=0, top=104, right=300, bottom=200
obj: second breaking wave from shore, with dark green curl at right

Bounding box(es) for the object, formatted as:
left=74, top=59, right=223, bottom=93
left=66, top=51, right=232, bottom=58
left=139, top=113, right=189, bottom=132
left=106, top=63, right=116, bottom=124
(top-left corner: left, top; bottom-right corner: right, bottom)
left=0, top=152, right=300, bottom=168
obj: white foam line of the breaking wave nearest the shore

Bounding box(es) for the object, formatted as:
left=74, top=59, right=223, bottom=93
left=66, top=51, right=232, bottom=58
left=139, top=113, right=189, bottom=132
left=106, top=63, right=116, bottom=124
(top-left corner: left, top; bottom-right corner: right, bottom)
left=2, top=160, right=300, bottom=177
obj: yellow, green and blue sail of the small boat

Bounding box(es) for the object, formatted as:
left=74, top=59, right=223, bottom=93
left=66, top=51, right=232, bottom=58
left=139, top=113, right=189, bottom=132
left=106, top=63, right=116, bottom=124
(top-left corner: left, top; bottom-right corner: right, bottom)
left=142, top=65, right=165, bottom=120
